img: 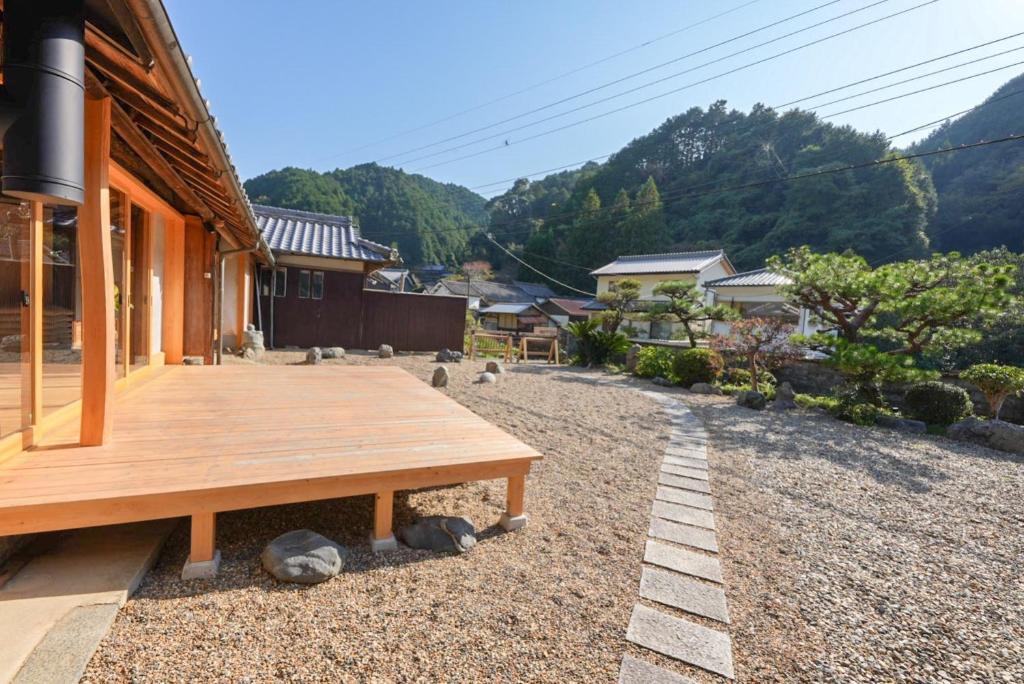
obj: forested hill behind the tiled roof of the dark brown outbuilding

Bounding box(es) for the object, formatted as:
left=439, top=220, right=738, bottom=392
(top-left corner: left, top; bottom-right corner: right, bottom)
left=245, top=164, right=487, bottom=265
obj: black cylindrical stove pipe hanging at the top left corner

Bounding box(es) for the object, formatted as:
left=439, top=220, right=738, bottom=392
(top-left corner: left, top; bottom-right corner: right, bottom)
left=0, top=0, right=85, bottom=206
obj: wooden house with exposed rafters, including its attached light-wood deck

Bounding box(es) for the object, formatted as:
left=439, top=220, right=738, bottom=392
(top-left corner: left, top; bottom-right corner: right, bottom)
left=0, top=0, right=540, bottom=589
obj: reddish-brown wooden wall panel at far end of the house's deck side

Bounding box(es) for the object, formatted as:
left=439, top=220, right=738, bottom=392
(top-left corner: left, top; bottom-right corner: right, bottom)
left=183, top=216, right=215, bottom=364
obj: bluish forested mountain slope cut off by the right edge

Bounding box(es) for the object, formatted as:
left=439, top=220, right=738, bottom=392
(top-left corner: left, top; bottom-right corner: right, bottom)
left=913, top=75, right=1024, bottom=253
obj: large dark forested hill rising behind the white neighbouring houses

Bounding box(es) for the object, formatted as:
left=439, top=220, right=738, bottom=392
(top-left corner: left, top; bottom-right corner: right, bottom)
left=488, top=101, right=936, bottom=287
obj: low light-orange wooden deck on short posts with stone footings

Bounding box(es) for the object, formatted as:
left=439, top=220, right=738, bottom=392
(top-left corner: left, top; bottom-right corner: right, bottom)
left=0, top=365, right=541, bottom=573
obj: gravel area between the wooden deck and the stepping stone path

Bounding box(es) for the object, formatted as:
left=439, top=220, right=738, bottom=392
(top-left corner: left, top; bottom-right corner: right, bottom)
left=83, top=352, right=669, bottom=682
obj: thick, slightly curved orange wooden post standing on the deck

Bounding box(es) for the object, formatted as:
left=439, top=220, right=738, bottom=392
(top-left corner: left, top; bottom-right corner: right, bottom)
left=78, top=97, right=115, bottom=446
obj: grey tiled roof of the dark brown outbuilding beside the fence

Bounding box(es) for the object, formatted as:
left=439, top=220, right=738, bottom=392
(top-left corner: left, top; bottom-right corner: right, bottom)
left=253, top=205, right=397, bottom=262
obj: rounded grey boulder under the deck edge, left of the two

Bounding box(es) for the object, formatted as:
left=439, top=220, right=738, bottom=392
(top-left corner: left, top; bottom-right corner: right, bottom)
left=260, top=529, right=347, bottom=585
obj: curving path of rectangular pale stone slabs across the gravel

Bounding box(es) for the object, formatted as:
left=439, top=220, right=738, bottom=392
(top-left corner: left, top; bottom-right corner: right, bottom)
left=548, top=375, right=735, bottom=684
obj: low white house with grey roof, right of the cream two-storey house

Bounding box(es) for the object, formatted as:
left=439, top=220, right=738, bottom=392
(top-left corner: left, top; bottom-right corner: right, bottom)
left=705, top=268, right=818, bottom=335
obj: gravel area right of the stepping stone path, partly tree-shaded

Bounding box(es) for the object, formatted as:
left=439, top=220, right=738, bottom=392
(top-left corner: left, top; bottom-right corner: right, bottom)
left=683, top=394, right=1024, bottom=682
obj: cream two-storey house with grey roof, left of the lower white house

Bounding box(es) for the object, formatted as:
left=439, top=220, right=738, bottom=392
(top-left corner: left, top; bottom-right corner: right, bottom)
left=583, top=250, right=736, bottom=339
